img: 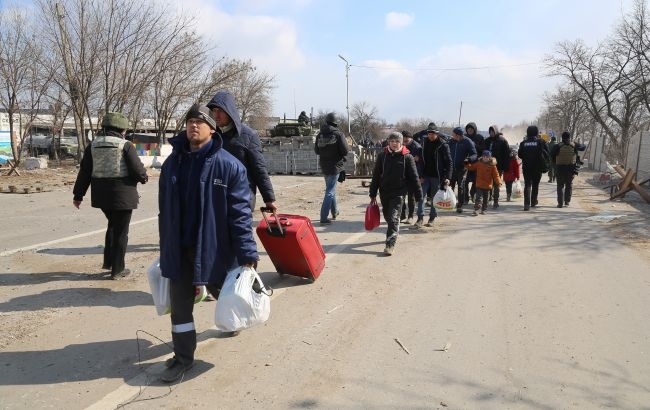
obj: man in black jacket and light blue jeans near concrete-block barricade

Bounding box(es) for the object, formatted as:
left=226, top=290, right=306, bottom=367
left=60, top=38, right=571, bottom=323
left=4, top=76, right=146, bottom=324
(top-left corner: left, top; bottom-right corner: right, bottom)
left=314, top=112, right=349, bottom=224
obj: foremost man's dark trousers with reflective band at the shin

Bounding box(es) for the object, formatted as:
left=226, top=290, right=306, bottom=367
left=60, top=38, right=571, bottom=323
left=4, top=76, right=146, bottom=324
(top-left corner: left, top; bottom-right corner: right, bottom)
left=169, top=248, right=219, bottom=364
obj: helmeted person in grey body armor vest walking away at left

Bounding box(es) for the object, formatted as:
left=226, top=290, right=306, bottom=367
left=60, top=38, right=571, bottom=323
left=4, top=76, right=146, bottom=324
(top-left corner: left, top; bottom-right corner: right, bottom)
left=72, top=112, right=149, bottom=279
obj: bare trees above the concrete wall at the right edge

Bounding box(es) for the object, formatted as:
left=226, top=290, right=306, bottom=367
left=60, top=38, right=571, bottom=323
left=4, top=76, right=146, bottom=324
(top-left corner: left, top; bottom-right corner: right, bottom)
left=538, top=0, right=650, bottom=162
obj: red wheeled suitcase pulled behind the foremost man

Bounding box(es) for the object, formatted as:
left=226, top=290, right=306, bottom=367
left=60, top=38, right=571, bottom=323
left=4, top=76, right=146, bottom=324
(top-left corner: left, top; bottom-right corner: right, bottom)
left=257, top=208, right=325, bottom=282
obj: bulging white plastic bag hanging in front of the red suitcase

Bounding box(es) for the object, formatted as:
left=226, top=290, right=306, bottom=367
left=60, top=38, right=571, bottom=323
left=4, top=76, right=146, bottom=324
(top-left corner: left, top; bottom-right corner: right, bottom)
left=214, top=266, right=271, bottom=332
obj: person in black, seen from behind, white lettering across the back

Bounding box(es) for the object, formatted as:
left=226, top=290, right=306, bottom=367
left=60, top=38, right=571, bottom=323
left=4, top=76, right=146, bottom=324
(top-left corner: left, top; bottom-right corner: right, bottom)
left=517, top=125, right=549, bottom=211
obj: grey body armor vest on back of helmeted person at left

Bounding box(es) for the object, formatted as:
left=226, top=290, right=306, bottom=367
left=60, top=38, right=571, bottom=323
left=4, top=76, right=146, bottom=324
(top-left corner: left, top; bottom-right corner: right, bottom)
left=90, top=135, right=129, bottom=178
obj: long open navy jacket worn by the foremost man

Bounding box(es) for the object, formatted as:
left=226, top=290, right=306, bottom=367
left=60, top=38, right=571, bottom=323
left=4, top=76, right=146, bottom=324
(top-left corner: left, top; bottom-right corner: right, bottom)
left=158, top=134, right=258, bottom=286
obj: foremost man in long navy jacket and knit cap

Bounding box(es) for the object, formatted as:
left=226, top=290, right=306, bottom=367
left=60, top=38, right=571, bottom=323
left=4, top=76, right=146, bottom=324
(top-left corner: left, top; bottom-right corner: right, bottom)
left=158, top=105, right=258, bottom=383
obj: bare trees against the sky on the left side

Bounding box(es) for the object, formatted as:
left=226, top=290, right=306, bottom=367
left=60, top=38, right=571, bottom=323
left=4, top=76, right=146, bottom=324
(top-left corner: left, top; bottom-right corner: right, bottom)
left=0, top=0, right=275, bottom=161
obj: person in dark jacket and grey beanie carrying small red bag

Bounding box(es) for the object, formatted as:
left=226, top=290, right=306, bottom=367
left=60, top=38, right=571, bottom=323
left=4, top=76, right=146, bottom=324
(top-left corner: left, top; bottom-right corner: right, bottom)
left=369, top=132, right=422, bottom=256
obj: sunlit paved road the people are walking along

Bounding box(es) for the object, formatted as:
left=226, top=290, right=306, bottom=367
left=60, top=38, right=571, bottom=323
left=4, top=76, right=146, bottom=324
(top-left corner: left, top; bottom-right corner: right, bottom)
left=0, top=177, right=650, bottom=409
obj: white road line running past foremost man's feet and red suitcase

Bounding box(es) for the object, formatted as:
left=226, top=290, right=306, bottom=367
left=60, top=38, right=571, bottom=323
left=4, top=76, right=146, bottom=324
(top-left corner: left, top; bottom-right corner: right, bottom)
left=86, top=227, right=368, bottom=410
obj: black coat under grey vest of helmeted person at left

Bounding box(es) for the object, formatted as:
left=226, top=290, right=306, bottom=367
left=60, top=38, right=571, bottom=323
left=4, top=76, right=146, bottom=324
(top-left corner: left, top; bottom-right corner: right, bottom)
left=72, top=131, right=148, bottom=210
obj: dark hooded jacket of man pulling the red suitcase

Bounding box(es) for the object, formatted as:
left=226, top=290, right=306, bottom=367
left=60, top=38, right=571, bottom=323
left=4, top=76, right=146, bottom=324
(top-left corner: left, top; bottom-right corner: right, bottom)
left=207, top=91, right=275, bottom=204
